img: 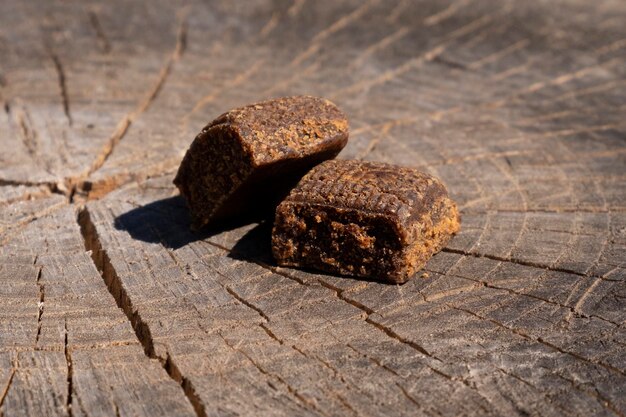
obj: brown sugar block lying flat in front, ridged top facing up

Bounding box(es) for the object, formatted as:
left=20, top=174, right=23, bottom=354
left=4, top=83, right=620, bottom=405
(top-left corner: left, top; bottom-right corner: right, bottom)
left=272, top=160, right=460, bottom=283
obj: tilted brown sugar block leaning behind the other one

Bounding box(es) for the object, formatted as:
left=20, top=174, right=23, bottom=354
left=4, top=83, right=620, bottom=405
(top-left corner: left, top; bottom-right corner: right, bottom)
left=174, top=96, right=348, bottom=228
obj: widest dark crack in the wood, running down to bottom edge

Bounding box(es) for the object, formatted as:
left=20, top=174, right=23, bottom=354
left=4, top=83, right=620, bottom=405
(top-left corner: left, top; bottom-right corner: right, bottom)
left=77, top=208, right=207, bottom=417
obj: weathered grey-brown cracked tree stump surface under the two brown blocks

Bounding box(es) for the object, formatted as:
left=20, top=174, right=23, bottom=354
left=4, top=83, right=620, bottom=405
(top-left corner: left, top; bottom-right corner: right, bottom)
left=0, top=0, right=626, bottom=417
